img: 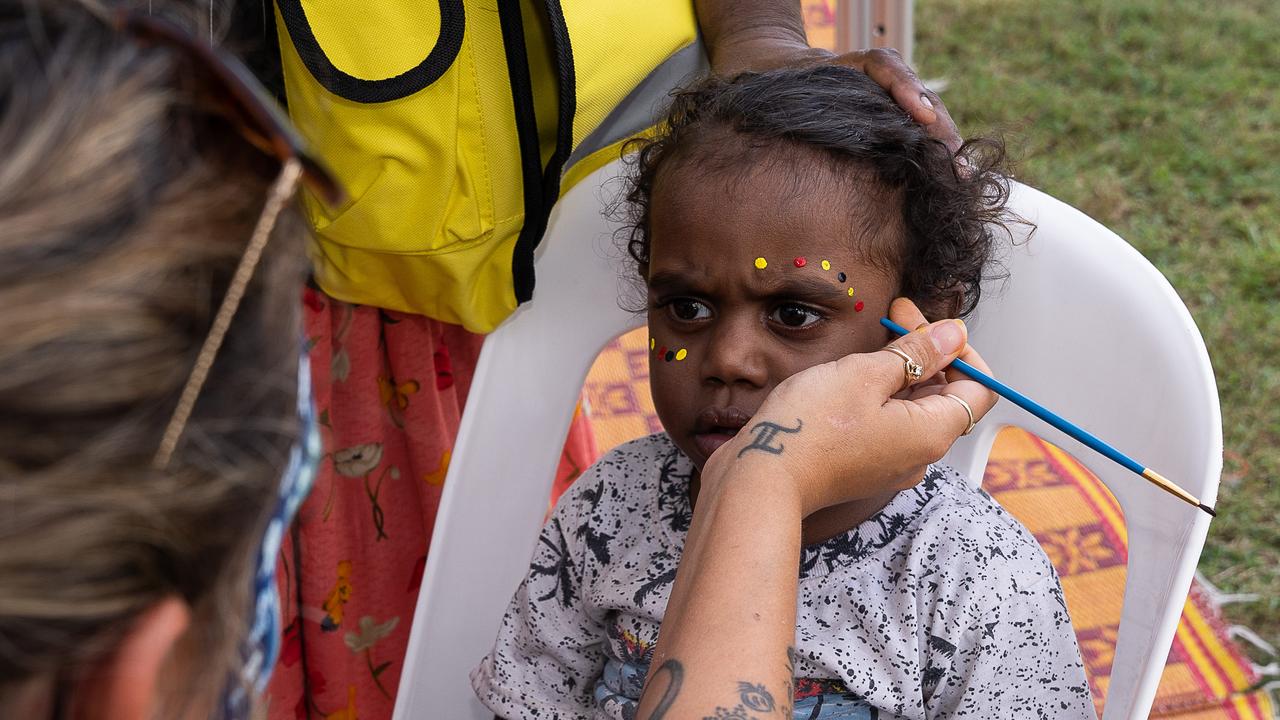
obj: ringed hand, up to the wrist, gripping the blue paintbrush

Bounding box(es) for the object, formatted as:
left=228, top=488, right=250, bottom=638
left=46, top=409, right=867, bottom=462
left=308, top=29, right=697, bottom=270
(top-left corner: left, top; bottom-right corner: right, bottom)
left=703, top=299, right=997, bottom=515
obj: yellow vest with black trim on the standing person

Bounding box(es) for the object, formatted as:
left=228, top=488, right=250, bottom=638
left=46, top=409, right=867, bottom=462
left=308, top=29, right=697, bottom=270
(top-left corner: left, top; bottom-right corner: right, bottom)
left=276, top=0, right=705, bottom=332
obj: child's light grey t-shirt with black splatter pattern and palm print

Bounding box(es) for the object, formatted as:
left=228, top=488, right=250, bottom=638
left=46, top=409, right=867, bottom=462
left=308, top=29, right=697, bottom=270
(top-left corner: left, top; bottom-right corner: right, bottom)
left=471, top=433, right=1096, bottom=720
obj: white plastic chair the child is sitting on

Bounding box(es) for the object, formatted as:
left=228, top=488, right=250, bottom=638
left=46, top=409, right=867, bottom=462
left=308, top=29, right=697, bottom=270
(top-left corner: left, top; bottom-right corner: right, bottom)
left=394, top=163, right=1221, bottom=720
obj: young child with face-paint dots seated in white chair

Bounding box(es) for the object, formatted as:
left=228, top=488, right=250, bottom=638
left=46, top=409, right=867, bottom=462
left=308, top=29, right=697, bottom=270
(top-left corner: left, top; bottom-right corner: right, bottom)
left=472, top=67, right=1094, bottom=720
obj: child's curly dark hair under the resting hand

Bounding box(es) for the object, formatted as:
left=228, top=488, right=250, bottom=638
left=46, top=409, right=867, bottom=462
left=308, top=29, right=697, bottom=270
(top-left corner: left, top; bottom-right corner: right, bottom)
left=626, top=65, right=1024, bottom=318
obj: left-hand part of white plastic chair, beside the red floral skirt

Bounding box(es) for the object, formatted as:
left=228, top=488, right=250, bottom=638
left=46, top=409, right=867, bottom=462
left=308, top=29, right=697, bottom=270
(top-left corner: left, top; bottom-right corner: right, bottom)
left=394, top=161, right=644, bottom=720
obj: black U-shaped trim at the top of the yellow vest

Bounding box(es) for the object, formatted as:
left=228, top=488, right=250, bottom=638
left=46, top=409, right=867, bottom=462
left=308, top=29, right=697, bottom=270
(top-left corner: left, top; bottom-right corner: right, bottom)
left=276, top=0, right=466, bottom=102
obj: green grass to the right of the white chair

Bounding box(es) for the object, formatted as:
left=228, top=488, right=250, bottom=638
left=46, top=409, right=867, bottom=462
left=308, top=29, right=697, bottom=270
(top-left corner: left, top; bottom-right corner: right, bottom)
left=915, top=0, right=1280, bottom=646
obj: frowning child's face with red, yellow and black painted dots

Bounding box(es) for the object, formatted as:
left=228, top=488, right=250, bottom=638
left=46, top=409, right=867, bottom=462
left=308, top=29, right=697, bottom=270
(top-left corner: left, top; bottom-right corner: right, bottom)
left=646, top=159, right=897, bottom=469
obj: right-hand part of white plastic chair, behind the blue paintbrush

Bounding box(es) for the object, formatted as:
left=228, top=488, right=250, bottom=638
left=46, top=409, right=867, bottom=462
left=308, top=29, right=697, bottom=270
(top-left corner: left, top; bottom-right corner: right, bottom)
left=947, top=184, right=1222, bottom=720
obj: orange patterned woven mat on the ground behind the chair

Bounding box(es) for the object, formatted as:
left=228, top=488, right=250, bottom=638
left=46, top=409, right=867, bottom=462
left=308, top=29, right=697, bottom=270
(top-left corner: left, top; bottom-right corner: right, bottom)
left=585, top=328, right=1275, bottom=720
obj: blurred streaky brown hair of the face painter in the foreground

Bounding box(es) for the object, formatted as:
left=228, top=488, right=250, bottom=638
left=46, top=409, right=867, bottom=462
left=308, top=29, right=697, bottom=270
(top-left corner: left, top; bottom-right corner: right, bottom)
left=0, top=0, right=305, bottom=717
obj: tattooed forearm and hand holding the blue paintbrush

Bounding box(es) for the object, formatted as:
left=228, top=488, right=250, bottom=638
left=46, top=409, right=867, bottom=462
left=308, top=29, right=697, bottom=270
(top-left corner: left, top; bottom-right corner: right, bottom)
left=637, top=300, right=996, bottom=720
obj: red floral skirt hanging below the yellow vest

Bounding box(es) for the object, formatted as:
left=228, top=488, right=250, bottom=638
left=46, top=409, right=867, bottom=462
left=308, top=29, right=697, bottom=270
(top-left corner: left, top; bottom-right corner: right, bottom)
left=268, top=290, right=595, bottom=720
